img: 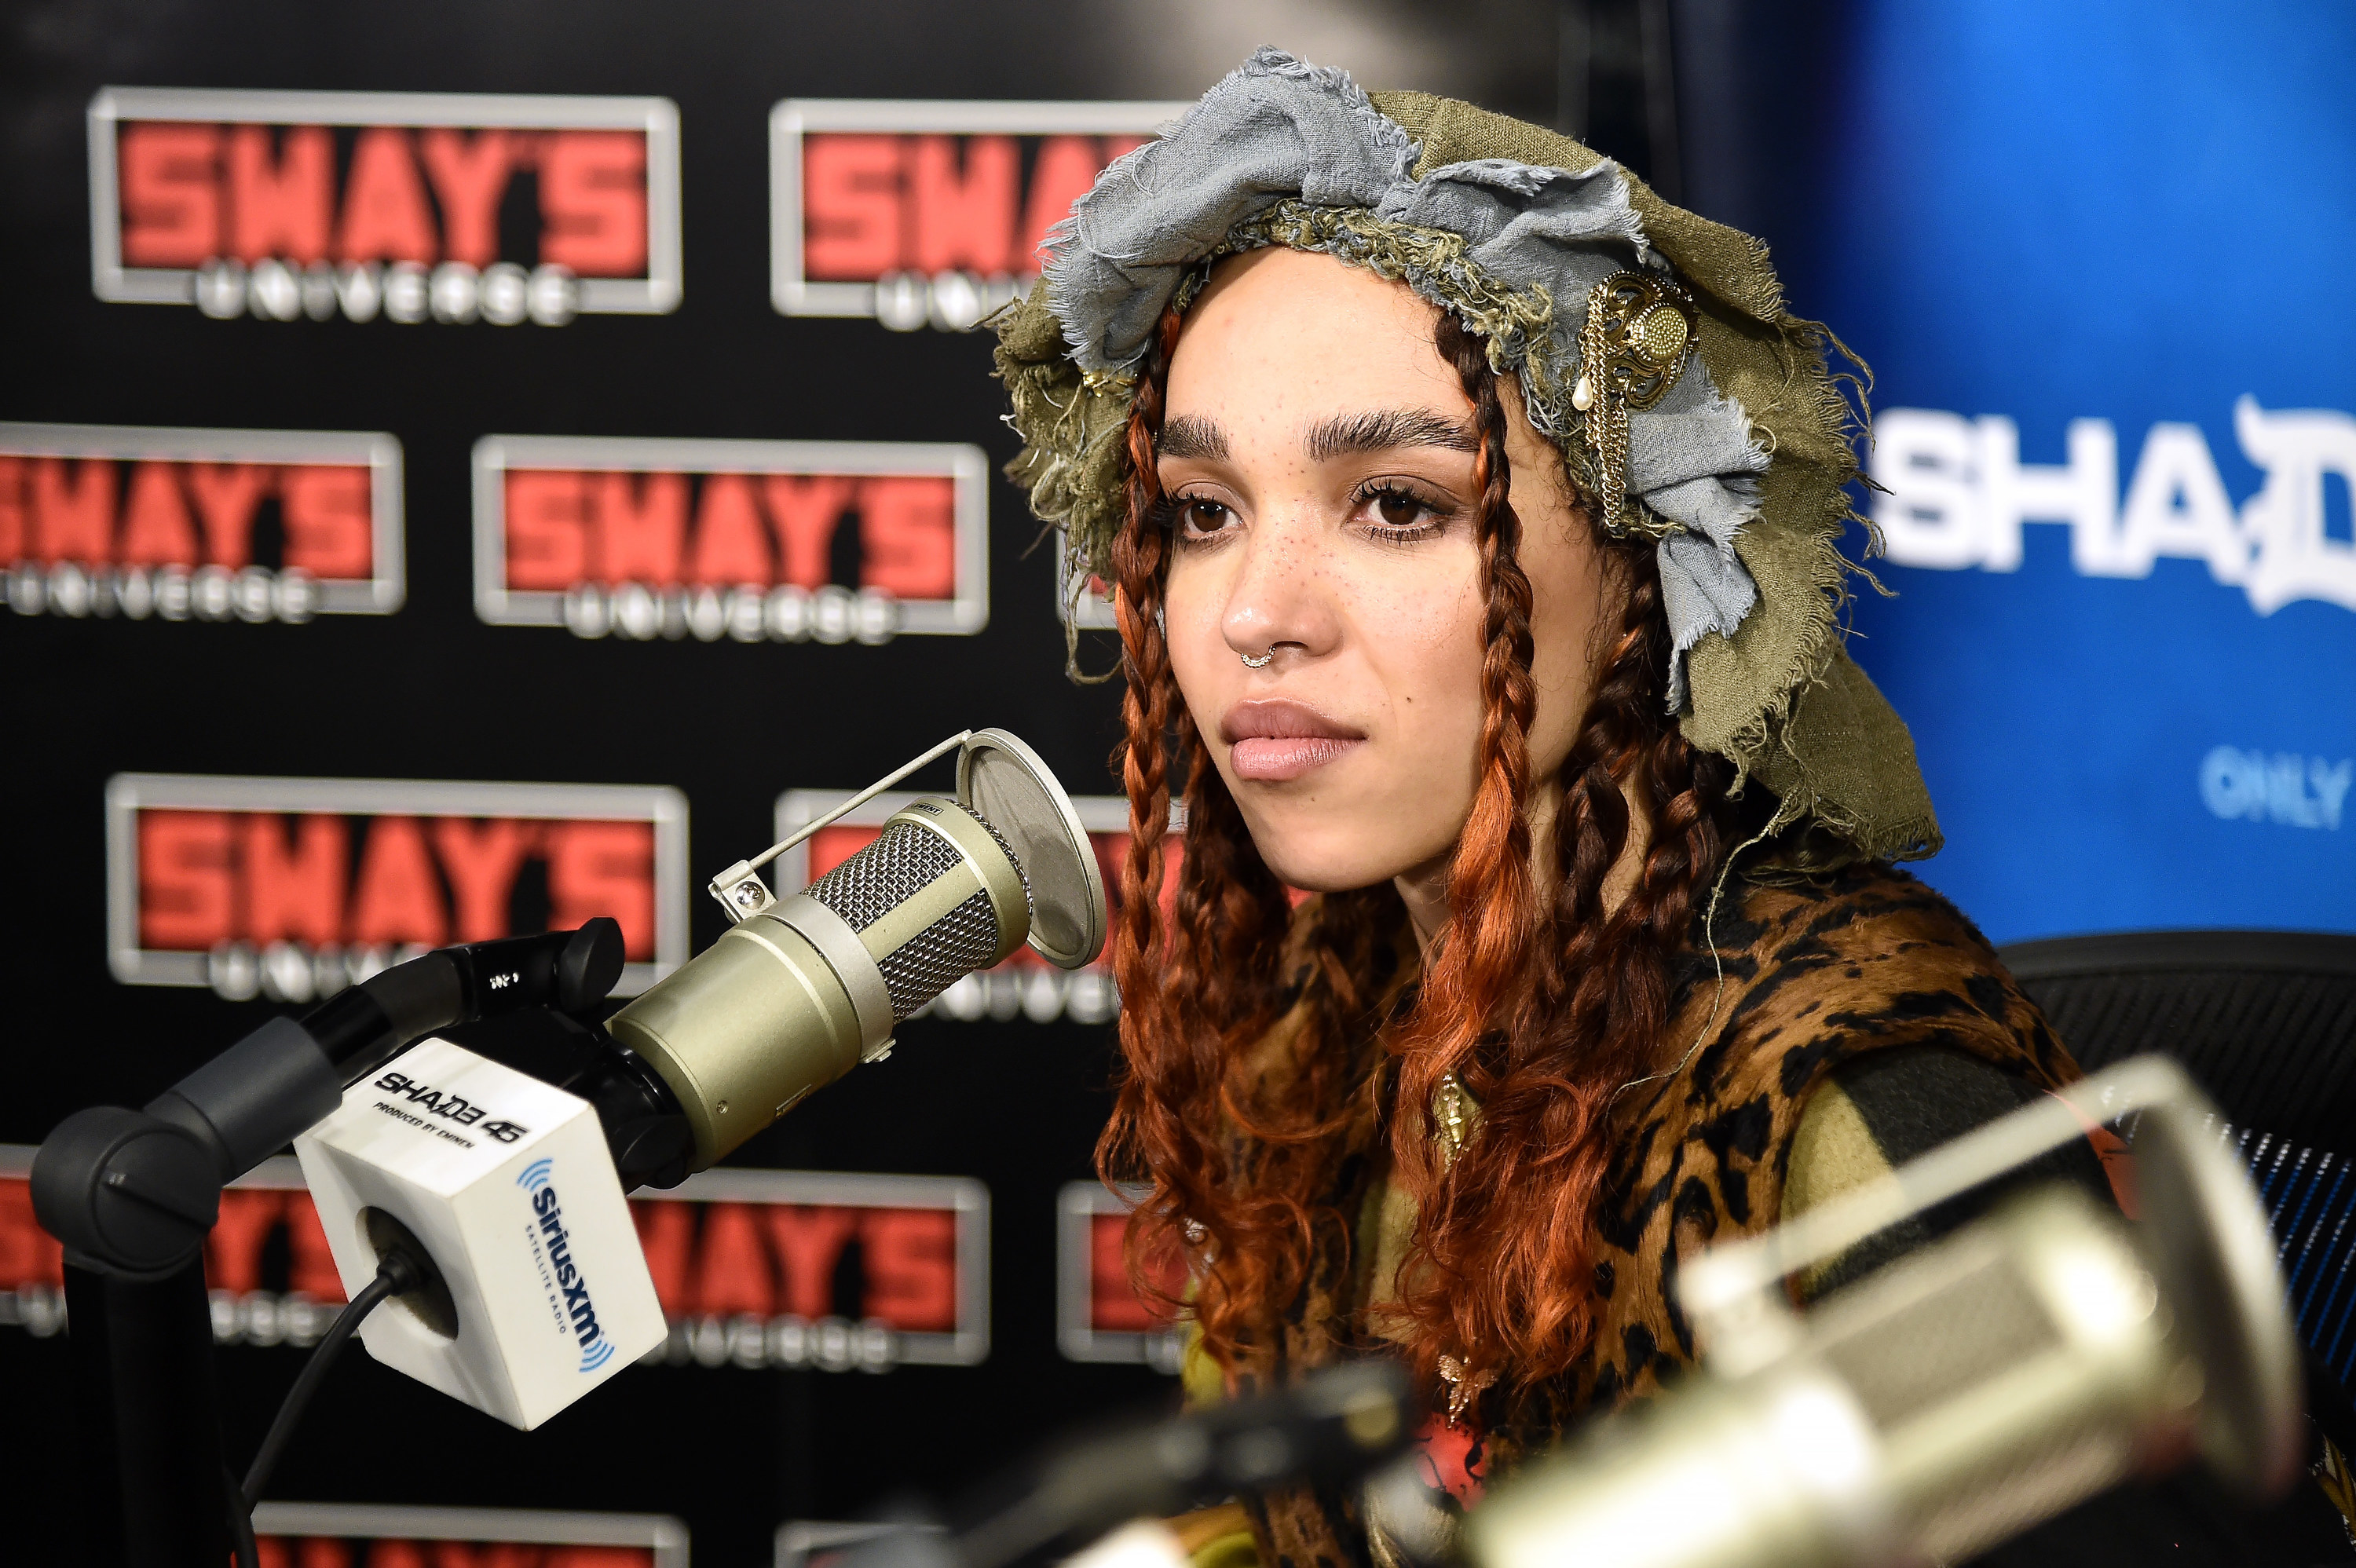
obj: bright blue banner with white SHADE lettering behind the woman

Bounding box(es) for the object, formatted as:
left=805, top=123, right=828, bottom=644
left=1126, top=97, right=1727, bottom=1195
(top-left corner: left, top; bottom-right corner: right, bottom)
left=1791, top=0, right=2356, bottom=941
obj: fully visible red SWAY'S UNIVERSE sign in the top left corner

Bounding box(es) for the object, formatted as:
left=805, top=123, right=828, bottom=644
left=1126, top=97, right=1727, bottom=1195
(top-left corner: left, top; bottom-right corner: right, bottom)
left=90, top=87, right=681, bottom=327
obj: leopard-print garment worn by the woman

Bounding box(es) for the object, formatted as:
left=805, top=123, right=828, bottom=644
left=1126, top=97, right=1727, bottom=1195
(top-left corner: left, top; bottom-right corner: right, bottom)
left=1232, top=861, right=2078, bottom=1568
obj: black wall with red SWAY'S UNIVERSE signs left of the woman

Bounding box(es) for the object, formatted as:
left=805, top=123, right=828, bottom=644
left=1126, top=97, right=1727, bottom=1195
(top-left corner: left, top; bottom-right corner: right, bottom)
left=0, top=5, right=1310, bottom=1568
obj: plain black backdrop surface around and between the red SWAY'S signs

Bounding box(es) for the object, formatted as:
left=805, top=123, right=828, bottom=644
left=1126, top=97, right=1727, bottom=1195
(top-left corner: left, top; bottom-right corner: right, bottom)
left=0, top=0, right=1753, bottom=1563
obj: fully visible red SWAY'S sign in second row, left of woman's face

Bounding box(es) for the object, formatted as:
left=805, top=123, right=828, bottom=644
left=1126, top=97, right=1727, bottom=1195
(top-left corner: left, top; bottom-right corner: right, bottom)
left=474, top=436, right=990, bottom=643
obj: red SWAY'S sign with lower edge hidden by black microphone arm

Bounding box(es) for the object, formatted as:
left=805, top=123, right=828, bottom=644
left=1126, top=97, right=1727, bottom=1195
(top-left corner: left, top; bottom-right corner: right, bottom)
left=106, top=773, right=688, bottom=1003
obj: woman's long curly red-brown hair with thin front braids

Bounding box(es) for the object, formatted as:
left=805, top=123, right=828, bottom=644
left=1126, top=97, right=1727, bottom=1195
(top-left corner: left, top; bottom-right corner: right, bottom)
left=1098, top=298, right=1732, bottom=1398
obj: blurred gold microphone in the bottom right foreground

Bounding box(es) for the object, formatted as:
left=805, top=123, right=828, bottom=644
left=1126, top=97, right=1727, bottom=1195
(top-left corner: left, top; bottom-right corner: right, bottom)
left=1468, top=1057, right=2299, bottom=1568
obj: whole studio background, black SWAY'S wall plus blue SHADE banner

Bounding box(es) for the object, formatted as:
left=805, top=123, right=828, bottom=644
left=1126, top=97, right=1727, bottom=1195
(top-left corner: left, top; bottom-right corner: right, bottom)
left=0, top=0, right=2356, bottom=1568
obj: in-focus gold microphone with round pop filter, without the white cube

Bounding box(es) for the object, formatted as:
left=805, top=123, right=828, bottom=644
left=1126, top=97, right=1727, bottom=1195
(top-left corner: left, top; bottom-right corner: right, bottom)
left=605, top=730, right=1105, bottom=1170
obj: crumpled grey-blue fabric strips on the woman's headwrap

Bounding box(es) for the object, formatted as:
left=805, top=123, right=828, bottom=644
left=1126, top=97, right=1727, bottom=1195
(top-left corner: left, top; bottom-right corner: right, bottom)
left=1044, top=49, right=1767, bottom=714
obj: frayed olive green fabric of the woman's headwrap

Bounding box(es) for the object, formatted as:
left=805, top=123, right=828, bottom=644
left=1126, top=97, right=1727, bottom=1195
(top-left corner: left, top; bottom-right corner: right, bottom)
left=997, top=60, right=1939, bottom=871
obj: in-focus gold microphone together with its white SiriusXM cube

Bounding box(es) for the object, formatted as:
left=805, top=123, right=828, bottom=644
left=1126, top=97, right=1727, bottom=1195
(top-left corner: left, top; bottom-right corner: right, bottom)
left=294, top=730, right=1105, bottom=1429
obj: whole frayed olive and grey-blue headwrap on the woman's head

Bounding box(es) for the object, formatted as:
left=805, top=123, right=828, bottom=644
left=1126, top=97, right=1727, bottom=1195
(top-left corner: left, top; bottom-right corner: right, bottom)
left=999, top=49, right=1939, bottom=868
